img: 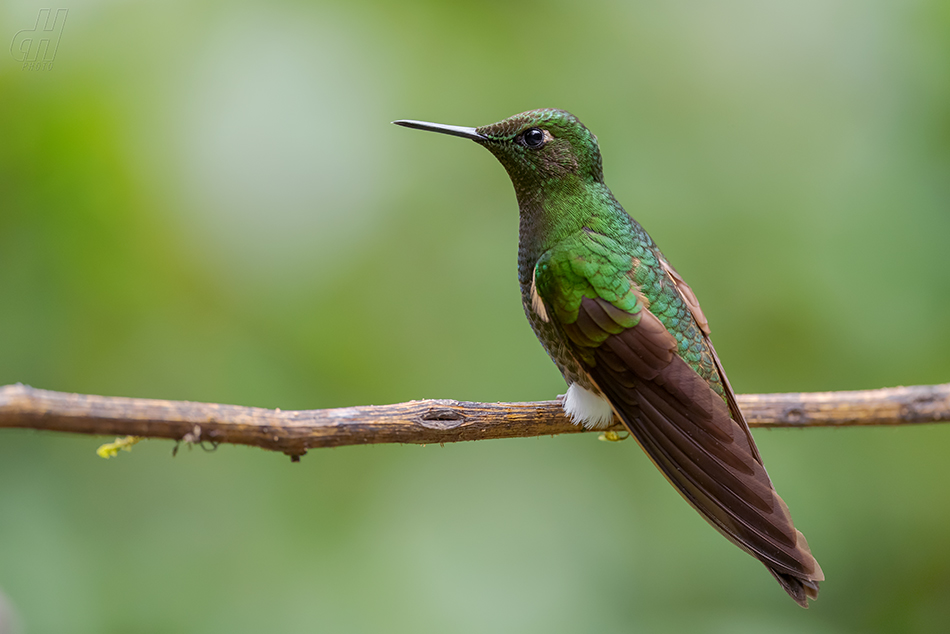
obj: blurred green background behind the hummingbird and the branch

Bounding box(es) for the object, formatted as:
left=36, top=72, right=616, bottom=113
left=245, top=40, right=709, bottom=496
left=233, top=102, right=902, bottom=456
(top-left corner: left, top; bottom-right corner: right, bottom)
left=0, top=0, right=950, bottom=634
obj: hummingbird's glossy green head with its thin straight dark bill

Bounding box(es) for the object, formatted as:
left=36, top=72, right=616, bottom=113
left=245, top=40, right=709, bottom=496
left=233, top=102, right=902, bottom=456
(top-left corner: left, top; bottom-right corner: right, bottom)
left=393, top=109, right=604, bottom=190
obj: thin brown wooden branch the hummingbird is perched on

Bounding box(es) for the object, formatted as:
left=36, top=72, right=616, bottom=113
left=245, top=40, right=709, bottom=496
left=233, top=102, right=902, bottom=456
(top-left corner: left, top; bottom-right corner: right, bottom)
left=0, top=383, right=950, bottom=458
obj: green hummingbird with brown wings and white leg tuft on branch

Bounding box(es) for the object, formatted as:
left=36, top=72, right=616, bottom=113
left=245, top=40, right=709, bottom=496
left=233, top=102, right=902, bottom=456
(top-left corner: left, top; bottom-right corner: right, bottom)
left=393, top=109, right=824, bottom=608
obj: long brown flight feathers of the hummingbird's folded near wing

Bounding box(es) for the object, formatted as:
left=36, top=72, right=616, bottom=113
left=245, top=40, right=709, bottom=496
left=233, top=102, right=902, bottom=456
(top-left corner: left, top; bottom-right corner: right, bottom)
left=563, top=291, right=824, bottom=607
